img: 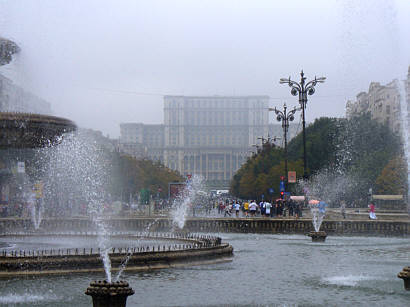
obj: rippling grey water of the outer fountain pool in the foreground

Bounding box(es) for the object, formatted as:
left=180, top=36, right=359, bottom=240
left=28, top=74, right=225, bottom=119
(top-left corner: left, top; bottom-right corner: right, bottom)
left=0, top=234, right=410, bottom=306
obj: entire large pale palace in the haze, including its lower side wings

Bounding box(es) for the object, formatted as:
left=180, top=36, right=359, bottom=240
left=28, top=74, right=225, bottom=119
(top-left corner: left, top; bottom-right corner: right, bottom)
left=120, top=96, right=301, bottom=187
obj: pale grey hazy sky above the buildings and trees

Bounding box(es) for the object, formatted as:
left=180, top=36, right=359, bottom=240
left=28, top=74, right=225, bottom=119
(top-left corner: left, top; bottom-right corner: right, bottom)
left=0, top=0, right=410, bottom=137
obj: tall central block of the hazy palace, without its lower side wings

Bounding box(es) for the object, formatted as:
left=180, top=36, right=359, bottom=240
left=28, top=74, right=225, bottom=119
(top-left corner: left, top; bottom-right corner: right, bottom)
left=164, top=96, right=269, bottom=186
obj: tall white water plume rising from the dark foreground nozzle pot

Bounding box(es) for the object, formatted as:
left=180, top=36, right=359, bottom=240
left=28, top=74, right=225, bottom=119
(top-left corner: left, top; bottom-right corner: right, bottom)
left=37, top=133, right=111, bottom=282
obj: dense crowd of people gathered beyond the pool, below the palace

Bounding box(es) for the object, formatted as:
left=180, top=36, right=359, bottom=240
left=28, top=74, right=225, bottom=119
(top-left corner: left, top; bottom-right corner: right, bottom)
left=215, top=199, right=303, bottom=218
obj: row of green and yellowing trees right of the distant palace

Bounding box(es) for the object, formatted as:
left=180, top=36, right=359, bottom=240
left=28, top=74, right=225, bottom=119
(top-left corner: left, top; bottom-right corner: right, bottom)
left=230, top=114, right=407, bottom=205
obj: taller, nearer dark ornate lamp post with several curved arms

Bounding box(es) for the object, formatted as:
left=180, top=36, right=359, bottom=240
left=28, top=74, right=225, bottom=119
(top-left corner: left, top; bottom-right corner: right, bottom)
left=279, top=70, right=326, bottom=179
